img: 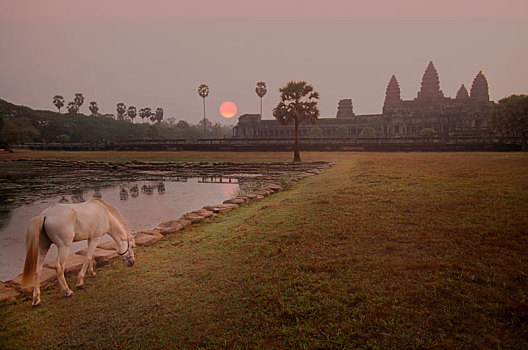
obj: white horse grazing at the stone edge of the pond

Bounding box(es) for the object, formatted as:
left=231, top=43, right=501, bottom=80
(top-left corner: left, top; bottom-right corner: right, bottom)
left=22, top=199, right=135, bottom=306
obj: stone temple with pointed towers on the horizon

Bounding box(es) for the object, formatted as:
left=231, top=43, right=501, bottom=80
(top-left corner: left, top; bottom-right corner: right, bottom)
left=233, top=62, right=494, bottom=138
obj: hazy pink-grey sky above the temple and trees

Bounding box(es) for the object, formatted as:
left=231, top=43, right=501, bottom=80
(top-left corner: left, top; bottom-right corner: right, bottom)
left=0, top=0, right=528, bottom=123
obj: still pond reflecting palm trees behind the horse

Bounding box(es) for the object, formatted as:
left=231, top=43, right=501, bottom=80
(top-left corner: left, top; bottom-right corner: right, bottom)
left=0, top=177, right=238, bottom=281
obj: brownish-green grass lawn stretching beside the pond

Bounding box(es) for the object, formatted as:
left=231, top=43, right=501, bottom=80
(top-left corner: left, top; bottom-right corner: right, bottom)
left=0, top=152, right=528, bottom=349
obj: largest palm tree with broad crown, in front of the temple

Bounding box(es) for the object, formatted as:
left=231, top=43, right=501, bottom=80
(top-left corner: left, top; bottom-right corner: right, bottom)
left=273, top=81, right=319, bottom=162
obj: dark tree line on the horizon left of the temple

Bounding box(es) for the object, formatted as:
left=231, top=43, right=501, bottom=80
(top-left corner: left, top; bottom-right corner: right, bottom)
left=0, top=100, right=232, bottom=150
